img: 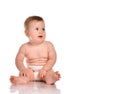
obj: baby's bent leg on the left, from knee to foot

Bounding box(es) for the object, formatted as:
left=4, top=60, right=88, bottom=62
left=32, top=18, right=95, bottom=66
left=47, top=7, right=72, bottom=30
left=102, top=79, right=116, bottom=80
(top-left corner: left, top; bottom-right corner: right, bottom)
left=10, top=69, right=34, bottom=84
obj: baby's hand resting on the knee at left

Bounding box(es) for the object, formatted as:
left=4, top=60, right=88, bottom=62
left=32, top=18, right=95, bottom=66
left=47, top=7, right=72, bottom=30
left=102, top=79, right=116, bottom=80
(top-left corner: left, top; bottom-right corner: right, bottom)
left=19, top=68, right=34, bottom=79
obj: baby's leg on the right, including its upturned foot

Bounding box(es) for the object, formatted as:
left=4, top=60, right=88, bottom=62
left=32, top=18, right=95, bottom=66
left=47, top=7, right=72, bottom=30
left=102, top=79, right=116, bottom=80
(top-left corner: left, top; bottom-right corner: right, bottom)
left=44, top=71, right=60, bottom=85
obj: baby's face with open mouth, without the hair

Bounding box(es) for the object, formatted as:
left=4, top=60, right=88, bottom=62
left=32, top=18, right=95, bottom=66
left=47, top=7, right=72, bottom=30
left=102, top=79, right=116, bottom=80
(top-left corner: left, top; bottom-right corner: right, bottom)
left=28, top=21, right=46, bottom=43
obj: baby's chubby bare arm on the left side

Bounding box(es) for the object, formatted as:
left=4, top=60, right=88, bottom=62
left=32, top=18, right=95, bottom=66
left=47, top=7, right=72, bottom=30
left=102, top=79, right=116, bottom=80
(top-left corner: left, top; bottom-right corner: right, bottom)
left=15, top=45, right=25, bottom=71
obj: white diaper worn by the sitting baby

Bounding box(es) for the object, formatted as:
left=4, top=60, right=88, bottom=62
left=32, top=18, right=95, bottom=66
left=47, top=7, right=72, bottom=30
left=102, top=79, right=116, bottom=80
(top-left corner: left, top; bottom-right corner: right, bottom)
left=28, top=65, right=43, bottom=80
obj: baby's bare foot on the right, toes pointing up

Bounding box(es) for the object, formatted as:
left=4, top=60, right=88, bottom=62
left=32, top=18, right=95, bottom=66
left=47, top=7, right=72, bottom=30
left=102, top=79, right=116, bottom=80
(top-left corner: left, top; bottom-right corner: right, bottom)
left=46, top=71, right=60, bottom=85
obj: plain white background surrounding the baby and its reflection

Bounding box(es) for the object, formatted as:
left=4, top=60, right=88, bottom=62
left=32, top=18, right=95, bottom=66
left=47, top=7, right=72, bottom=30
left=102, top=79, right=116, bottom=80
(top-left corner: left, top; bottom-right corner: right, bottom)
left=0, top=0, right=120, bottom=94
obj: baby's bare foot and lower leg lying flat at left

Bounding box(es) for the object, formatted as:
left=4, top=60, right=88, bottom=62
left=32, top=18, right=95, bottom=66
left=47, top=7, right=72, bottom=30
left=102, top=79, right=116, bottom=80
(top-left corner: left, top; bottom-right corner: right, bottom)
left=10, top=76, right=29, bottom=84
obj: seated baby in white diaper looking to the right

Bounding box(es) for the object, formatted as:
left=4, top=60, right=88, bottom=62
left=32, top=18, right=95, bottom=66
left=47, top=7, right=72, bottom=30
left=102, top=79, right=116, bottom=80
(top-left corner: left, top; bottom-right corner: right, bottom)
left=10, top=16, right=60, bottom=85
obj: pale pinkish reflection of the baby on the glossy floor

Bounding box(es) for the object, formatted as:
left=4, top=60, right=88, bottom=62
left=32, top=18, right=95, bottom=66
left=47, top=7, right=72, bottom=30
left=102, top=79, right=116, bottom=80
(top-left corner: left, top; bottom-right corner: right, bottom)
left=10, top=82, right=60, bottom=94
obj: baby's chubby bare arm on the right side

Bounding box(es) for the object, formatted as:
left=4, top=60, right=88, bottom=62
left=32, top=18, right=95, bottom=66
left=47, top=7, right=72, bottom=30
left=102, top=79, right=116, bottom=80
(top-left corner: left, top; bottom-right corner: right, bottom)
left=43, top=42, right=57, bottom=71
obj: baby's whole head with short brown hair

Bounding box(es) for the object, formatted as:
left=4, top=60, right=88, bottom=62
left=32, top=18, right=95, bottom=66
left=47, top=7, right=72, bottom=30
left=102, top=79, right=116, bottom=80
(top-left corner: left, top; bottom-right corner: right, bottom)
left=24, top=16, right=46, bottom=43
